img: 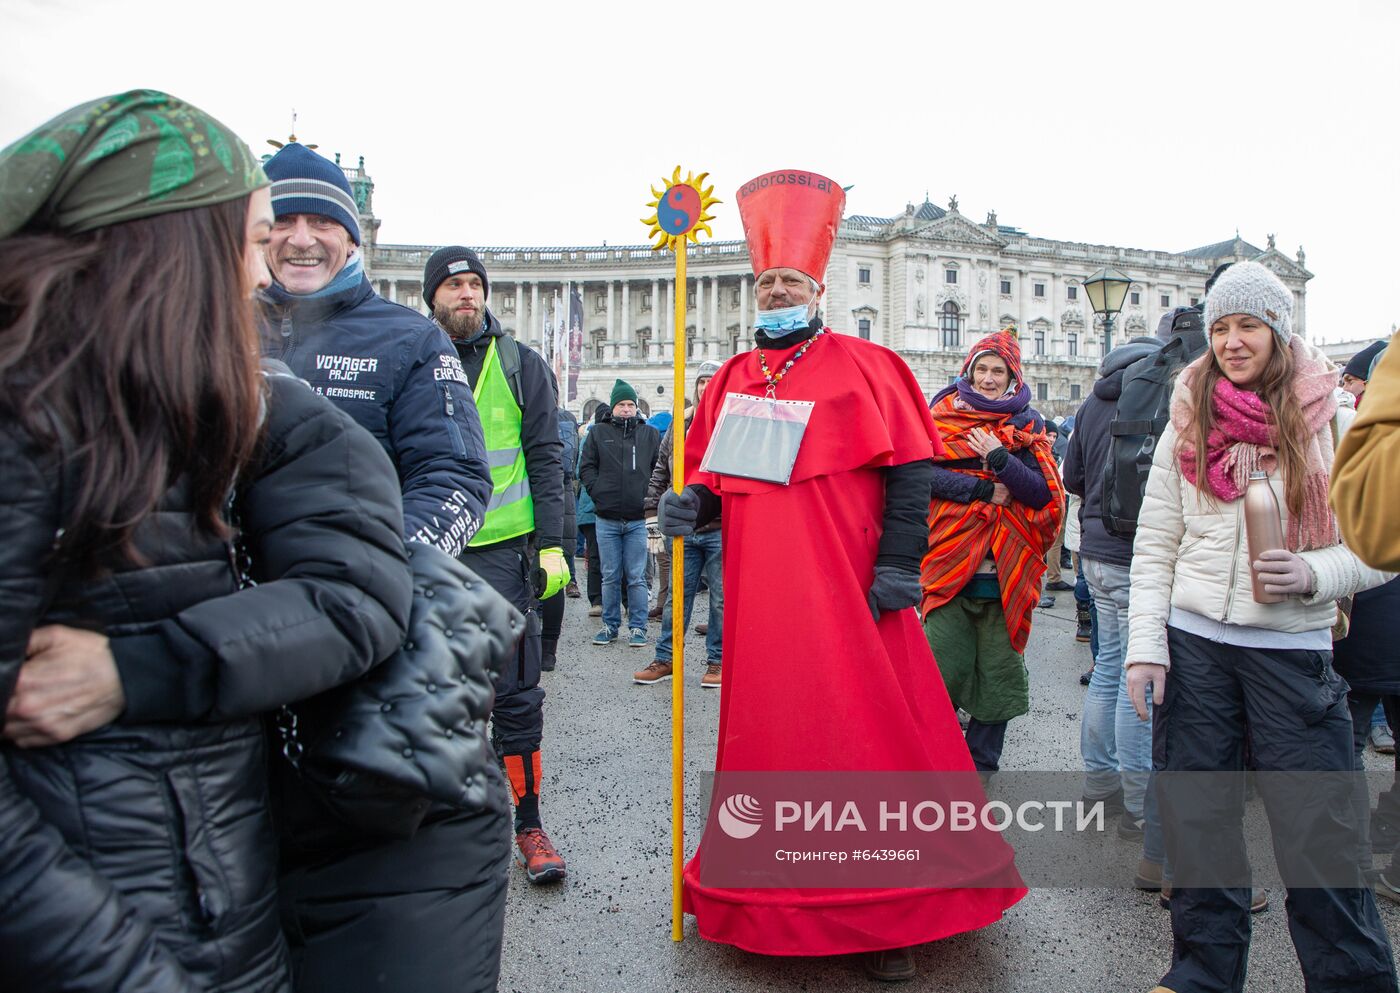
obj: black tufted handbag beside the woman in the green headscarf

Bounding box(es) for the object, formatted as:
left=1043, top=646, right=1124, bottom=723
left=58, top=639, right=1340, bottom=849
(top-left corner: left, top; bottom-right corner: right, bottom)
left=274, top=542, right=525, bottom=863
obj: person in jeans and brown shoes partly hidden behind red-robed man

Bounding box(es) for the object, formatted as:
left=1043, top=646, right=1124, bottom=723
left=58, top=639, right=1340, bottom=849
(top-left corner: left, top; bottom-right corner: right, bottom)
left=631, top=360, right=724, bottom=689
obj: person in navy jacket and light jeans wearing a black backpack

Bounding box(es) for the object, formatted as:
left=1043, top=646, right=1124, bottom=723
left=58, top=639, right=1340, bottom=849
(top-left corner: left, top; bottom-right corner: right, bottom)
left=1061, top=338, right=1162, bottom=882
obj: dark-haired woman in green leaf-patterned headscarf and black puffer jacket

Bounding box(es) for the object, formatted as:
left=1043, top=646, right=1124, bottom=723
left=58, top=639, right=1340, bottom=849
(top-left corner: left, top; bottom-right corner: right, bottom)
left=0, top=90, right=412, bottom=993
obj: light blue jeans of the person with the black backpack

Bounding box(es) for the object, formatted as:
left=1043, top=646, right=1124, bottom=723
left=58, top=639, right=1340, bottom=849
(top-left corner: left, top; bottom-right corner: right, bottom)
left=1079, top=559, right=1152, bottom=817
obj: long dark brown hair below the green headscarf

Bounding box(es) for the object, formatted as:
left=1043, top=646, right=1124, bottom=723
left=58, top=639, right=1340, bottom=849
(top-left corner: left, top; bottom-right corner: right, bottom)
left=0, top=196, right=260, bottom=571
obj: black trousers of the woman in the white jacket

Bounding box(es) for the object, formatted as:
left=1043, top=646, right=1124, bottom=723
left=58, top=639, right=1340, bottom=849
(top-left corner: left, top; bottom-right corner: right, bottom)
left=1152, top=627, right=1397, bottom=993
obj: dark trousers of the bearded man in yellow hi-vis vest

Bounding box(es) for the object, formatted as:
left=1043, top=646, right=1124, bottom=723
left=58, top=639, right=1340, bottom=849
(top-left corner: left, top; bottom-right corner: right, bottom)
left=461, top=538, right=545, bottom=755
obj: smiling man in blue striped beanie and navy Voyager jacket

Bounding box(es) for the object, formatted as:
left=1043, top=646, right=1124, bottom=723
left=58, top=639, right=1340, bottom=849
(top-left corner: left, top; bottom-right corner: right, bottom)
left=263, top=141, right=491, bottom=555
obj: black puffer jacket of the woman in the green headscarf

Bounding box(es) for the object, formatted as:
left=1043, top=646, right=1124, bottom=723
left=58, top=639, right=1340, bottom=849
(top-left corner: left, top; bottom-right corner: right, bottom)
left=0, top=377, right=410, bottom=993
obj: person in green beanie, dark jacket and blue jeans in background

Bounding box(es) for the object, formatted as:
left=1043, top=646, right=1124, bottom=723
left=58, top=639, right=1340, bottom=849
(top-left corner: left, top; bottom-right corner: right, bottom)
left=578, top=380, right=661, bottom=648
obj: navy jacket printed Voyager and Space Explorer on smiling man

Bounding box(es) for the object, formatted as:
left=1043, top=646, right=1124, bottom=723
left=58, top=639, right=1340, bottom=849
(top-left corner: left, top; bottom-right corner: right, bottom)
left=260, top=279, right=491, bottom=556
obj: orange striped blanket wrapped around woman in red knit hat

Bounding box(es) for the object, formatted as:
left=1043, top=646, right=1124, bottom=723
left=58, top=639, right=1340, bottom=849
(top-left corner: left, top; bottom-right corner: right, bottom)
left=918, top=394, right=1064, bottom=651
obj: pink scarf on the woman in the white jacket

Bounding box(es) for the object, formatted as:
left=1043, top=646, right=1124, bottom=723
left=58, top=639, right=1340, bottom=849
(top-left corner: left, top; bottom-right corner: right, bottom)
left=1172, top=338, right=1341, bottom=552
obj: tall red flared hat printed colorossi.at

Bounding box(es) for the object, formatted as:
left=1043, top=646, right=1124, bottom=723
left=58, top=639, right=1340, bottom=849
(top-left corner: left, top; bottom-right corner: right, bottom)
left=735, top=169, right=846, bottom=283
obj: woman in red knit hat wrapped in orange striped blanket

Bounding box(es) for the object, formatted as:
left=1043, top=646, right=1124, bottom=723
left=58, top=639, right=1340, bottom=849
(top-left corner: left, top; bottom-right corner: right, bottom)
left=920, top=331, right=1064, bottom=773
